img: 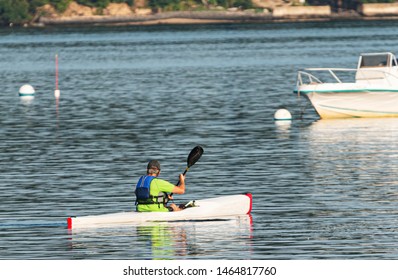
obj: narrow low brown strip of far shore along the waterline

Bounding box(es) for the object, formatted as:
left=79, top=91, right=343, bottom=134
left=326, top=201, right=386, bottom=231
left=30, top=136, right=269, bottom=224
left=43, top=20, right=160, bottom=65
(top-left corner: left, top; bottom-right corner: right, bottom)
left=31, top=11, right=398, bottom=26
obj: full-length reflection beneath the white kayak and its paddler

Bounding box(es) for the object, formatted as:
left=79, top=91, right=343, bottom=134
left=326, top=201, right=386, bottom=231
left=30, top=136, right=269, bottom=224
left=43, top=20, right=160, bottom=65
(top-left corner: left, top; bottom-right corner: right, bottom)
left=66, top=215, right=253, bottom=260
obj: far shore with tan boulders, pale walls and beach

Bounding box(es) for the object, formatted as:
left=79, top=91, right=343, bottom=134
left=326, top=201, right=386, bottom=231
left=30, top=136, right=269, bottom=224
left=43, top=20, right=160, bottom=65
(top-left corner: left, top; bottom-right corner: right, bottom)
left=31, top=0, right=398, bottom=26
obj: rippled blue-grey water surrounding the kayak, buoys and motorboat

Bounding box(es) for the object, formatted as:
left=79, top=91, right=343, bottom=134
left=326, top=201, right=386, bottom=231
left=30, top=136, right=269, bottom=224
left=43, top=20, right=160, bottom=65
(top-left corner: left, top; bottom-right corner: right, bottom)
left=0, top=22, right=398, bottom=259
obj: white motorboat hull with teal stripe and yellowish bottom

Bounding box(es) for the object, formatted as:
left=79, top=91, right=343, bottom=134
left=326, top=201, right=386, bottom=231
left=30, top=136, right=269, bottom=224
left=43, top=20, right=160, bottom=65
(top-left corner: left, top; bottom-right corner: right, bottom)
left=298, top=86, right=398, bottom=119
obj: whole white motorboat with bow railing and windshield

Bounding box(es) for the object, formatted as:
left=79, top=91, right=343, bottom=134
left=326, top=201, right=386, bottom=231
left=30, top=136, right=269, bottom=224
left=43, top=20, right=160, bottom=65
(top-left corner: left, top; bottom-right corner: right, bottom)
left=294, top=52, right=398, bottom=119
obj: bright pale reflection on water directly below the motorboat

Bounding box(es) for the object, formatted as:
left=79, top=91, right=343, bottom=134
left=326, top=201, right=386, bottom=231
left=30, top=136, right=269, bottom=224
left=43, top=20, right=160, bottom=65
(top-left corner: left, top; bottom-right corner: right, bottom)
left=303, top=118, right=398, bottom=189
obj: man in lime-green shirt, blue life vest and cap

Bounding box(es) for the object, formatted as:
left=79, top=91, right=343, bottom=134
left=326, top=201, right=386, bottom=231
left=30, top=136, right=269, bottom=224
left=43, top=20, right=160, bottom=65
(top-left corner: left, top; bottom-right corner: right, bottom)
left=135, top=160, right=185, bottom=212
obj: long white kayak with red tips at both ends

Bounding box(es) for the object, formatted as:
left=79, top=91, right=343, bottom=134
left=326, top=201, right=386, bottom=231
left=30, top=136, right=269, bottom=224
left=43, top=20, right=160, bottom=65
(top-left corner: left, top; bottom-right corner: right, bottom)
left=67, top=193, right=253, bottom=229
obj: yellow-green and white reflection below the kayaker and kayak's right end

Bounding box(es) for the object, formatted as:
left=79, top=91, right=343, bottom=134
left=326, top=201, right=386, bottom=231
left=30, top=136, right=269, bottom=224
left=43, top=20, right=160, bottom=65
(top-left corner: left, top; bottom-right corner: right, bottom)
left=136, top=215, right=252, bottom=260
